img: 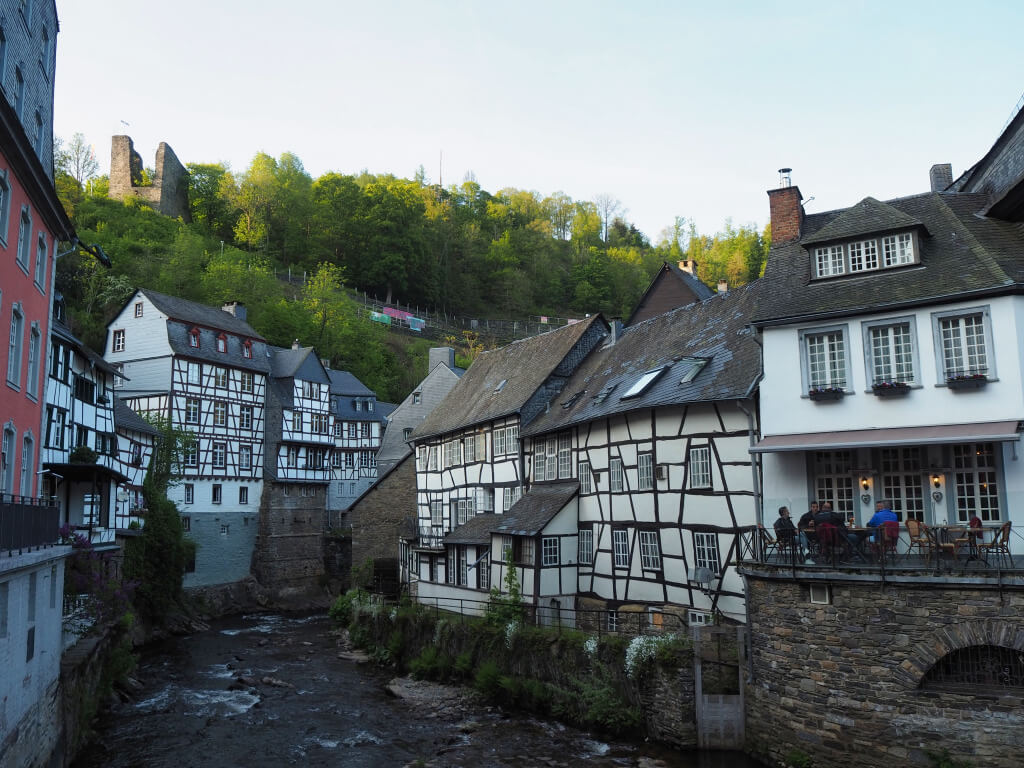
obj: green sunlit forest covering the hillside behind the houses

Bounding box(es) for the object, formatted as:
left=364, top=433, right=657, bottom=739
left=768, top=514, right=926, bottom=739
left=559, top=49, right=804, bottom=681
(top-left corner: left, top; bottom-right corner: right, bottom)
left=48, top=134, right=769, bottom=401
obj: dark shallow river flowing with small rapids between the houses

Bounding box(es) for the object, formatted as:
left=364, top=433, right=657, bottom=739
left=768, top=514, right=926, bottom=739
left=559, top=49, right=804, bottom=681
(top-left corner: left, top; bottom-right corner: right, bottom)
left=73, top=615, right=760, bottom=768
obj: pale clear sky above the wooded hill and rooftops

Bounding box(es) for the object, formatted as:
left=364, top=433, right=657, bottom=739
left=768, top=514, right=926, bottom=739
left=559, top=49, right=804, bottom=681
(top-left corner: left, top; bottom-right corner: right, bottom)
left=54, top=0, right=1024, bottom=243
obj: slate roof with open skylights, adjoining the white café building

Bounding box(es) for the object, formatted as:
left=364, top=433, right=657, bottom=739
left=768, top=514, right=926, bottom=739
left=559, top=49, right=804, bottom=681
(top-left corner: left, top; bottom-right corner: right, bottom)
left=521, top=281, right=763, bottom=435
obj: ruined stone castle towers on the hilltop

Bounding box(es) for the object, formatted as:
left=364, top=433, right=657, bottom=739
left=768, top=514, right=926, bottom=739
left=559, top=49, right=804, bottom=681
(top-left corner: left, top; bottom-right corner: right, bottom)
left=110, top=136, right=191, bottom=221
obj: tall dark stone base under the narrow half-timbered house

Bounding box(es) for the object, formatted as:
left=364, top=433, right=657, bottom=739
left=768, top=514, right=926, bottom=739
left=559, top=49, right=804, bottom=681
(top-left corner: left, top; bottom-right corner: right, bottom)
left=253, top=482, right=327, bottom=603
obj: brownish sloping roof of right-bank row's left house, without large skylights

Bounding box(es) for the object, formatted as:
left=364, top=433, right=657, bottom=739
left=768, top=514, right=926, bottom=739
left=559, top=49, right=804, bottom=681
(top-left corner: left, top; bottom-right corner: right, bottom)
left=413, top=314, right=604, bottom=439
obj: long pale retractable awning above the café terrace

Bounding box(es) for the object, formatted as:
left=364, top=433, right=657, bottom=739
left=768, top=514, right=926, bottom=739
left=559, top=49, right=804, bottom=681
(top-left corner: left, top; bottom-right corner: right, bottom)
left=751, top=420, right=1024, bottom=454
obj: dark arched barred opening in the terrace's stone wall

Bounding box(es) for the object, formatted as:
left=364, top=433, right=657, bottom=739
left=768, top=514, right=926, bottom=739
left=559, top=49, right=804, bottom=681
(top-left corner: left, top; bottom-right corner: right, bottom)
left=921, top=645, right=1024, bottom=695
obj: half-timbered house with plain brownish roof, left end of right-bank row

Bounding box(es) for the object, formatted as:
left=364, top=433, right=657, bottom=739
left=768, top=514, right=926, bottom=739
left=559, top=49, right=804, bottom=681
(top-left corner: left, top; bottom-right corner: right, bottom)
left=411, top=315, right=608, bottom=611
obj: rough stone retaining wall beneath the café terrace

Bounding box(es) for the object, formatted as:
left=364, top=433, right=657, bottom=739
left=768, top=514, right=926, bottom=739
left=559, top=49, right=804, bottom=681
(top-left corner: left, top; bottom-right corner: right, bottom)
left=746, top=570, right=1024, bottom=768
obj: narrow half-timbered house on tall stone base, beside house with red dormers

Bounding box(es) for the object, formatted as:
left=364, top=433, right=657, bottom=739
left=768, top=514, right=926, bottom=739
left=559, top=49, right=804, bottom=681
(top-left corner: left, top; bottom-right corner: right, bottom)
left=253, top=341, right=334, bottom=597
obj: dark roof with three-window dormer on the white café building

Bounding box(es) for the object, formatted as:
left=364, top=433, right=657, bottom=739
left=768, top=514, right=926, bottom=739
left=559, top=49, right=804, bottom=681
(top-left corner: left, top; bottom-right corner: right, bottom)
left=751, top=193, right=1024, bottom=326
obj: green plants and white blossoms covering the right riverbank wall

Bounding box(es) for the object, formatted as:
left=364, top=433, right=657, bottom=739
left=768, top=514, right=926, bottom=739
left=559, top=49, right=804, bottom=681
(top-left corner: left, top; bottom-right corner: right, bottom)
left=331, top=590, right=692, bottom=736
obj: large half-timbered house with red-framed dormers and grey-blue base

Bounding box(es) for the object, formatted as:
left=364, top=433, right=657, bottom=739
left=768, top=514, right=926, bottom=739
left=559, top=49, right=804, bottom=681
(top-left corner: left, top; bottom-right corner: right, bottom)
left=104, top=289, right=270, bottom=587
